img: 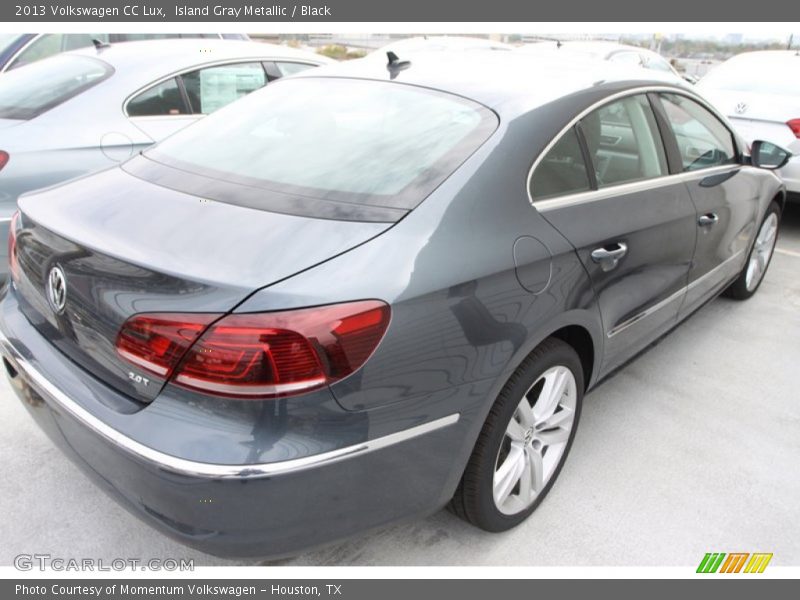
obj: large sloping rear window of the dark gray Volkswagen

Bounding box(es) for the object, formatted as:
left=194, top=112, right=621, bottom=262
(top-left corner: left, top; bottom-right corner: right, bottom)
left=145, top=78, right=497, bottom=210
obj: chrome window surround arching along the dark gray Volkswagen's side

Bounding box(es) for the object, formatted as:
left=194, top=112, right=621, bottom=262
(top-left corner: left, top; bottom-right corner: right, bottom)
left=525, top=85, right=743, bottom=211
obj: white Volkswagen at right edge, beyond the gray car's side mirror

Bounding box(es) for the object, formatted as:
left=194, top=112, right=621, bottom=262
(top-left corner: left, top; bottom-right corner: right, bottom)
left=698, top=50, right=800, bottom=201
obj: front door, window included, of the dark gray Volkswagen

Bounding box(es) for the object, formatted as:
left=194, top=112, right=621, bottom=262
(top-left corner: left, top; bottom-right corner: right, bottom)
left=657, top=93, right=759, bottom=314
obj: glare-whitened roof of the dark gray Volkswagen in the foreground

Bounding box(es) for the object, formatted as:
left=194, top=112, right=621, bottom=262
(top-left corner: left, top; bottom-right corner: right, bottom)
left=296, top=52, right=687, bottom=118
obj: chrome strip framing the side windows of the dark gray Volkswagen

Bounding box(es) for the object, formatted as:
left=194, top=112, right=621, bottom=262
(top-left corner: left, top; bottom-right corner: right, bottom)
left=525, top=85, right=743, bottom=210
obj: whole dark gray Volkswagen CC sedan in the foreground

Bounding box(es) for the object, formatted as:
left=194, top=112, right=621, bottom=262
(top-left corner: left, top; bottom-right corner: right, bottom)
left=0, top=53, right=787, bottom=556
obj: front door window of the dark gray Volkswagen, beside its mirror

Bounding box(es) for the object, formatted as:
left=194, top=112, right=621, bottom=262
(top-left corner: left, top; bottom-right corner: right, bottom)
left=659, top=94, right=738, bottom=171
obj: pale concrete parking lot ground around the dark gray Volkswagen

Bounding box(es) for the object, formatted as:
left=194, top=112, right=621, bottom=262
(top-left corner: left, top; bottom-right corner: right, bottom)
left=0, top=204, right=800, bottom=566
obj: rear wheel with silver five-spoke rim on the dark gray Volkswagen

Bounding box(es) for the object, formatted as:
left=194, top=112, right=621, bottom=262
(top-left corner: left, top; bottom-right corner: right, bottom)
left=451, top=339, right=583, bottom=531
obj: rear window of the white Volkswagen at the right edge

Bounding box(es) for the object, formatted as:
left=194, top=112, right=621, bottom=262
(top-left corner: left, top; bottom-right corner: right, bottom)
left=700, top=55, right=800, bottom=96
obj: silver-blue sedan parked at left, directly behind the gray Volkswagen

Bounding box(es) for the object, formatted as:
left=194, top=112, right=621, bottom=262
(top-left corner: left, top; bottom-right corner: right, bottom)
left=0, top=39, right=332, bottom=278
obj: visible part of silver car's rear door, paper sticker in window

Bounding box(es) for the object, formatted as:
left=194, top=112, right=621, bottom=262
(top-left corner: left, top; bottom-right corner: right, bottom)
left=125, top=61, right=267, bottom=142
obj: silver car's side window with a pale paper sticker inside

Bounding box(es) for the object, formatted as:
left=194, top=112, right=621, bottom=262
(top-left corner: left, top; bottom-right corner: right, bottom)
left=181, top=62, right=267, bottom=115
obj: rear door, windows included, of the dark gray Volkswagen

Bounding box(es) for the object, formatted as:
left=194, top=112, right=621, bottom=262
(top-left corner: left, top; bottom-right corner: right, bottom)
left=530, top=94, right=697, bottom=372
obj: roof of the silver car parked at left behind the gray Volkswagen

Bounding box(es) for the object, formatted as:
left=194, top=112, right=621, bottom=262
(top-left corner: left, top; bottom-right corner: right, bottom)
left=61, top=39, right=333, bottom=91
